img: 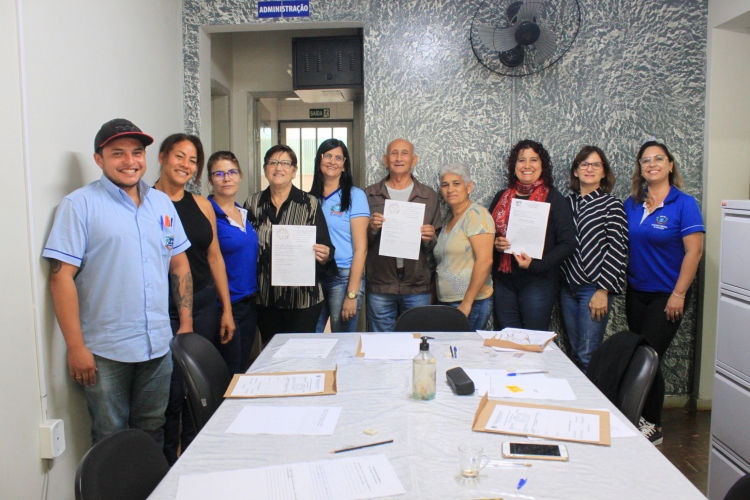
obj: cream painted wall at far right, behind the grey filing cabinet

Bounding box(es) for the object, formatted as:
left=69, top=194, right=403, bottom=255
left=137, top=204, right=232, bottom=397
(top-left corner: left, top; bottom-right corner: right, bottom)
left=694, top=0, right=750, bottom=408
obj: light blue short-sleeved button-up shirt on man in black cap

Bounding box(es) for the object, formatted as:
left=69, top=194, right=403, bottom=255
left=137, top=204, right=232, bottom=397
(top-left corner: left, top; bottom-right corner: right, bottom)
left=42, top=175, right=190, bottom=363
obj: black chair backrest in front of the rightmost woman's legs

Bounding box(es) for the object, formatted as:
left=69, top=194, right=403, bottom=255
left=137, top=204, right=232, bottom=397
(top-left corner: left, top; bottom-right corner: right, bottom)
left=615, top=345, right=659, bottom=427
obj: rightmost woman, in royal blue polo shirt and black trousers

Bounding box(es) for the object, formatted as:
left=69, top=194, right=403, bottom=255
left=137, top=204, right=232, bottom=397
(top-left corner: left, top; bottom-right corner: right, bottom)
left=625, top=141, right=706, bottom=444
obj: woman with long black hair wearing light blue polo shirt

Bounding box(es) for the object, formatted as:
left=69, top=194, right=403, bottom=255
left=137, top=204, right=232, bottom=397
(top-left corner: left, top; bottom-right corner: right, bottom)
left=310, top=139, right=370, bottom=333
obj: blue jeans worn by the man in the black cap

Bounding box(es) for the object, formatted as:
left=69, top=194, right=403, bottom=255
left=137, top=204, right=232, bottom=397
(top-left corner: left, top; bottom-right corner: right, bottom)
left=84, top=353, right=172, bottom=447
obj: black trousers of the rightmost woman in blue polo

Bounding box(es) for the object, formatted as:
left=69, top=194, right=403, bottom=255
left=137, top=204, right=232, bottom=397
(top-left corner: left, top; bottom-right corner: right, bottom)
left=625, top=286, right=693, bottom=427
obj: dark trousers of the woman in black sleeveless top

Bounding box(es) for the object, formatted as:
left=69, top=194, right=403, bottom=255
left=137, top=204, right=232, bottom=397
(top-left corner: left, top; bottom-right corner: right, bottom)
left=164, top=283, right=221, bottom=465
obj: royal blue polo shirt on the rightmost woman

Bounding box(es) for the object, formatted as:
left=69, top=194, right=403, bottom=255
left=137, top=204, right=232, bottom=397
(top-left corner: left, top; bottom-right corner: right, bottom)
left=625, top=186, right=706, bottom=293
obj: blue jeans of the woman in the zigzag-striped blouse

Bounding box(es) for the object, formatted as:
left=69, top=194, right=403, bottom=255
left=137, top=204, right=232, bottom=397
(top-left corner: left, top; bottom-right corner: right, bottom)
left=560, top=281, right=614, bottom=373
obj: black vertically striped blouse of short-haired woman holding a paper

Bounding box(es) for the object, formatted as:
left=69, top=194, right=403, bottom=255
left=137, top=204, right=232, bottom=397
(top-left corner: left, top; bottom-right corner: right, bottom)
left=245, top=186, right=336, bottom=309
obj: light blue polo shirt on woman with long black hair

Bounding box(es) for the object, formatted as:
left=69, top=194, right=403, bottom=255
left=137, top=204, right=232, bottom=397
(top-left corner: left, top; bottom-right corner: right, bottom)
left=321, top=186, right=370, bottom=269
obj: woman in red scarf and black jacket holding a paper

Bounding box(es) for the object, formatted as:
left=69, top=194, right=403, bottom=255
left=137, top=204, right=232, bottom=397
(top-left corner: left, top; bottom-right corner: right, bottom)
left=490, top=139, right=576, bottom=330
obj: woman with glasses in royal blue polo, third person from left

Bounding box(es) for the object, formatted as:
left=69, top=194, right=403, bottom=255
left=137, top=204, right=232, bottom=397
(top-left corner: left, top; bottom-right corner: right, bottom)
left=208, top=151, right=258, bottom=373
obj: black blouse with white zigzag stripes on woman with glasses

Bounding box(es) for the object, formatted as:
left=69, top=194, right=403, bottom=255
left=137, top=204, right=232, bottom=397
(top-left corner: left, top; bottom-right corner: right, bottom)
left=562, top=189, right=628, bottom=294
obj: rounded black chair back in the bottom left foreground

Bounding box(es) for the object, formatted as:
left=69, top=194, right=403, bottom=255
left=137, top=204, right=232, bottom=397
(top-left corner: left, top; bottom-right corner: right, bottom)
left=75, top=429, right=169, bottom=500
